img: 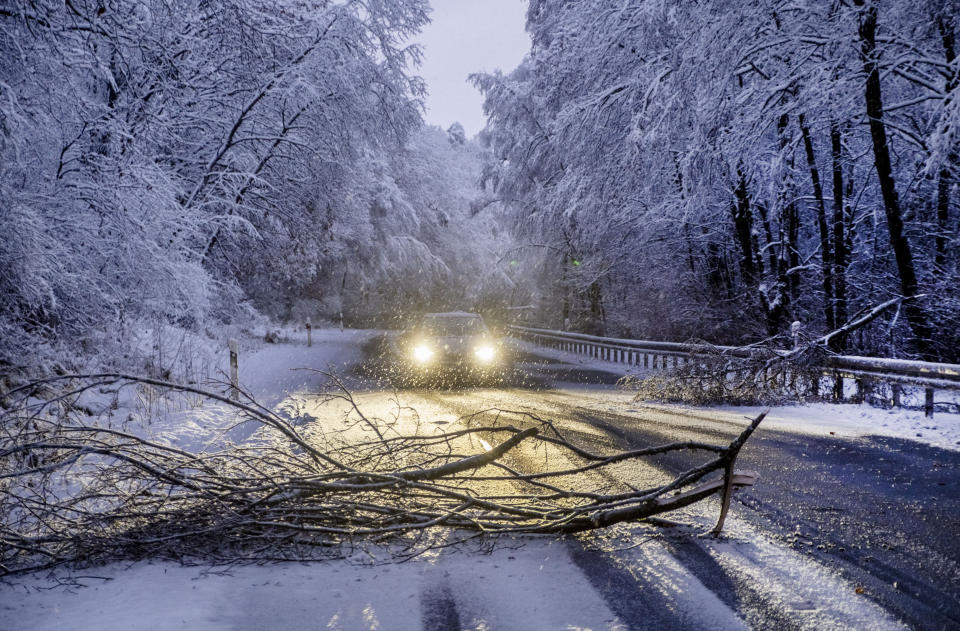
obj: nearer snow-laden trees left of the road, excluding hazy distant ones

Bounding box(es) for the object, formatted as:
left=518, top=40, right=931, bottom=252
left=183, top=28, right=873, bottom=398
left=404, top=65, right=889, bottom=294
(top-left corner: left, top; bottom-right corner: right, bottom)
left=0, top=0, right=428, bottom=362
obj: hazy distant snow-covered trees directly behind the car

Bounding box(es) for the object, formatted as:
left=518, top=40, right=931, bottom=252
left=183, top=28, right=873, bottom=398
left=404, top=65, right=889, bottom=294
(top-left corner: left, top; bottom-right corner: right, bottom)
left=319, top=127, right=511, bottom=328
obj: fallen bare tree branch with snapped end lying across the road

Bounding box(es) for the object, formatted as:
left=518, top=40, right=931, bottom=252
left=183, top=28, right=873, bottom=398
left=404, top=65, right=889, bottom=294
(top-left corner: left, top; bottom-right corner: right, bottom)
left=0, top=373, right=764, bottom=574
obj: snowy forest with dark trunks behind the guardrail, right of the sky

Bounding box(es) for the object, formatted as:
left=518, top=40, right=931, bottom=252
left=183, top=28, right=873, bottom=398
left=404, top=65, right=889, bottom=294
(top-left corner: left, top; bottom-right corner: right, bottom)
left=474, top=0, right=960, bottom=361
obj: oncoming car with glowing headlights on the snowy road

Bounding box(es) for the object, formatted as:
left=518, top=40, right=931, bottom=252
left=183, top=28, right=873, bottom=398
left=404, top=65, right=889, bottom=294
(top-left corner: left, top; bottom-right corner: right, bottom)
left=399, top=311, right=509, bottom=380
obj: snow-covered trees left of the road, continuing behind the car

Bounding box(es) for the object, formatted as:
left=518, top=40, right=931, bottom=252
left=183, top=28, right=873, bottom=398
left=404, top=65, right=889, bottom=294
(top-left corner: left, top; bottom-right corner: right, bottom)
left=0, top=0, right=507, bottom=376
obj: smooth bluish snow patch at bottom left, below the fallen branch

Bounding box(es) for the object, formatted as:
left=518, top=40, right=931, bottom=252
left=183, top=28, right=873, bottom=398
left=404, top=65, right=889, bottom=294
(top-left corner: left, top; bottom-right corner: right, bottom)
left=0, top=540, right=640, bottom=631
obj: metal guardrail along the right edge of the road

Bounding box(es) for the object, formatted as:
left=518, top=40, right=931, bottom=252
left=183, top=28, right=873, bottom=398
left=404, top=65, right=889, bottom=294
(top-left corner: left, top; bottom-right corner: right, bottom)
left=509, top=326, right=960, bottom=417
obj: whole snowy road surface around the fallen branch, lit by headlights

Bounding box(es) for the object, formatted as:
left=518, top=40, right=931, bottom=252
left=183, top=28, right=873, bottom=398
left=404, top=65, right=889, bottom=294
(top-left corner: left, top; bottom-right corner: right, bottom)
left=0, top=332, right=960, bottom=631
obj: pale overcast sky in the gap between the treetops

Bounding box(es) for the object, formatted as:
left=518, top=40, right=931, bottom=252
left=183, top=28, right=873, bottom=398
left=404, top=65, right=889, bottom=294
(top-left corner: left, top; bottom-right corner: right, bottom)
left=416, top=0, right=530, bottom=137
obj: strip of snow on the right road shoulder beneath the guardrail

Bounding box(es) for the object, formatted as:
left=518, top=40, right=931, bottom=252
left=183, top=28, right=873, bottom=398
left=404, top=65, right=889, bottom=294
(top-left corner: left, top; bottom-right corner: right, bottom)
left=514, top=341, right=960, bottom=451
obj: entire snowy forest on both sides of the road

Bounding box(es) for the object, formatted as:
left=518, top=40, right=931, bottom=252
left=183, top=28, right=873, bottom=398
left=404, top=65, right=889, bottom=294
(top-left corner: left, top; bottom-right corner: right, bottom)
left=0, top=0, right=960, bottom=366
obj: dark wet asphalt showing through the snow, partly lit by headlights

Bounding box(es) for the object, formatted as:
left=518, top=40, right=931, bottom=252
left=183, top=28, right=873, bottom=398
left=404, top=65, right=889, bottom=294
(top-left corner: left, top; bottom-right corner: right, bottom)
left=354, top=344, right=960, bottom=629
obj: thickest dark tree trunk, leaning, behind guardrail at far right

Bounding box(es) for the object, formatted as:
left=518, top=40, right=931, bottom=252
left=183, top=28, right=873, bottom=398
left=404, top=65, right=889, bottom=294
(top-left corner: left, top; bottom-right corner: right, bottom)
left=857, top=0, right=933, bottom=359
